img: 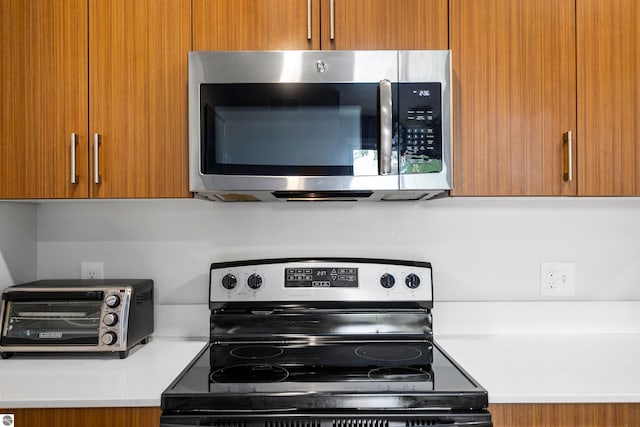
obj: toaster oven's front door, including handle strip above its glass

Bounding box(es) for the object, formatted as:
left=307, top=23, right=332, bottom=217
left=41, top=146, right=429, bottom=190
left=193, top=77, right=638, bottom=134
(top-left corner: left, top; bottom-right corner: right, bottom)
left=0, top=291, right=103, bottom=346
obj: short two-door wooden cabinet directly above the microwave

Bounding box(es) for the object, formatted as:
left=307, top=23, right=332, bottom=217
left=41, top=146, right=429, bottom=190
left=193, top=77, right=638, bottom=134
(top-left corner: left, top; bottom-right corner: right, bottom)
left=193, top=0, right=448, bottom=50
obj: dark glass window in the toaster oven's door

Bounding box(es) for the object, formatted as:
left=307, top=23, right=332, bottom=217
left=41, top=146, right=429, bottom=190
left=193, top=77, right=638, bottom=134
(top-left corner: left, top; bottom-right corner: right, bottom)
left=2, top=300, right=102, bottom=345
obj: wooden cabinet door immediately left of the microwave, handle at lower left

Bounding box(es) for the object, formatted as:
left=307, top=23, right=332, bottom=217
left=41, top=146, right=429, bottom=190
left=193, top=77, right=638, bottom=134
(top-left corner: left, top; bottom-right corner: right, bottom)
left=89, top=0, right=191, bottom=198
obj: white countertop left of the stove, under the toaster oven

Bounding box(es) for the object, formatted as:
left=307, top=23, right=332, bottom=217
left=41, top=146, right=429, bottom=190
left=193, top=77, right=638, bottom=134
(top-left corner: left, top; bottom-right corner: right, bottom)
left=0, top=338, right=206, bottom=408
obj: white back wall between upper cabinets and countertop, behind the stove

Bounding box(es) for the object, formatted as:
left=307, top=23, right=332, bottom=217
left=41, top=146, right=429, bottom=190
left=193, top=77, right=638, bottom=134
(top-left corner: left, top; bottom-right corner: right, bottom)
left=35, top=198, right=640, bottom=305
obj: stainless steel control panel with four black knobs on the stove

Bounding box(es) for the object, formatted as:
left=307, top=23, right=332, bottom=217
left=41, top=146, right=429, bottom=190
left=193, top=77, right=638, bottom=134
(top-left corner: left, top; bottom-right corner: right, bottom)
left=209, top=258, right=433, bottom=302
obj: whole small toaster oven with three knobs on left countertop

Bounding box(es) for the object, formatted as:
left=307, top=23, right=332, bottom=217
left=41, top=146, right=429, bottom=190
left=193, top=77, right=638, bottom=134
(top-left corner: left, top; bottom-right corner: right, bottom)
left=0, top=279, right=154, bottom=359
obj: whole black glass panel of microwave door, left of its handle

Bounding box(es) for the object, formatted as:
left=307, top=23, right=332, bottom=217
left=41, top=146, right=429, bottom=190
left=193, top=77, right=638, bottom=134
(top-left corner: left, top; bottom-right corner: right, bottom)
left=200, top=83, right=390, bottom=176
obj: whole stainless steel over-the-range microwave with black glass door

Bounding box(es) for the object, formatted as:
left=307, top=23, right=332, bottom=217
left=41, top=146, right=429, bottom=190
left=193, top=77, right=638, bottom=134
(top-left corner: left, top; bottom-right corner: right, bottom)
left=189, top=51, right=452, bottom=201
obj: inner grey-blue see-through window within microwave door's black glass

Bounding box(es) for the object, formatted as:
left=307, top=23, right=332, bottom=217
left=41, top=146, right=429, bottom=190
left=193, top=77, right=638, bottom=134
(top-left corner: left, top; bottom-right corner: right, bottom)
left=215, top=106, right=362, bottom=166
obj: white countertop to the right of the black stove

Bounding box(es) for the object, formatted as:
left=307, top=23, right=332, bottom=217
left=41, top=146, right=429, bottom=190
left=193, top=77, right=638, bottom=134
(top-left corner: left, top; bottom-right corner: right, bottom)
left=436, top=334, right=640, bottom=403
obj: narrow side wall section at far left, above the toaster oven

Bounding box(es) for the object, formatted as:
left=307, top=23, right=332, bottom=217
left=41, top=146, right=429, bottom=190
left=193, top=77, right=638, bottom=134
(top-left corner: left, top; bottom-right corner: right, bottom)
left=0, top=202, right=37, bottom=289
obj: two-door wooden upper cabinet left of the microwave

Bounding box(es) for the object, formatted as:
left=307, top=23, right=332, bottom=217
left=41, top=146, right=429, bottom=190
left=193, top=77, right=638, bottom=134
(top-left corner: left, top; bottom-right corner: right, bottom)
left=0, top=0, right=191, bottom=199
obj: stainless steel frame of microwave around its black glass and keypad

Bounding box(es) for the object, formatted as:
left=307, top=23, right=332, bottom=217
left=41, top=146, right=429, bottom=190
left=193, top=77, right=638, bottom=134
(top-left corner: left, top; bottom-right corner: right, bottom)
left=189, top=50, right=452, bottom=201
